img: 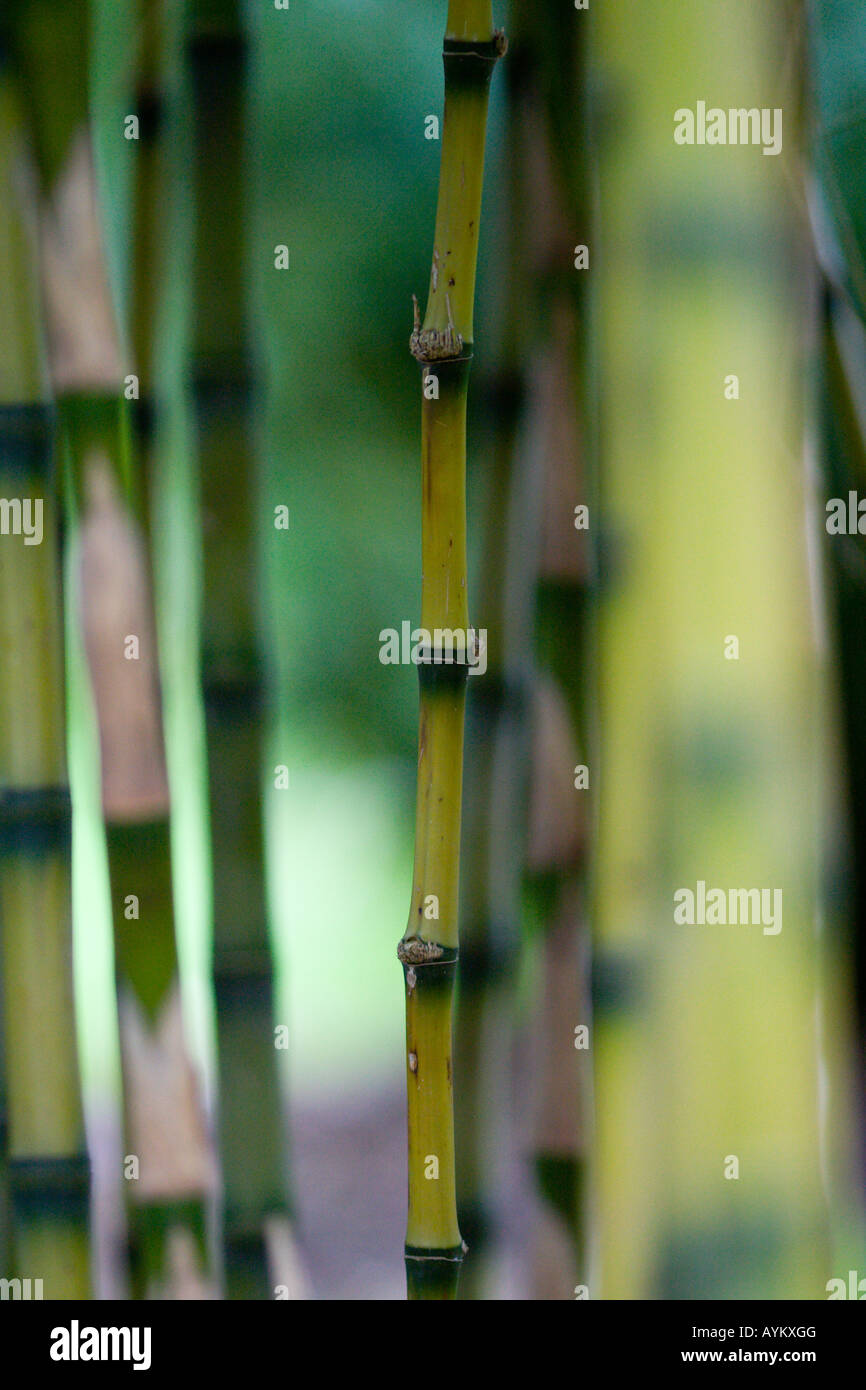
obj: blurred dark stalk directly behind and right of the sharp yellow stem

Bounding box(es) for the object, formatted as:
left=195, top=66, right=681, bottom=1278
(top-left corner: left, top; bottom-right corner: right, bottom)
left=455, top=6, right=541, bottom=1300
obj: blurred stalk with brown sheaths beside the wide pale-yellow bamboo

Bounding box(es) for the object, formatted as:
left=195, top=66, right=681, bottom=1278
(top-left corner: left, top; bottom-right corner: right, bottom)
left=517, top=3, right=598, bottom=1298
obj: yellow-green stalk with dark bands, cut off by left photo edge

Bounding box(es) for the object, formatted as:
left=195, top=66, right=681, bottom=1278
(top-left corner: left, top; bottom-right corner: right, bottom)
left=0, top=62, right=90, bottom=1298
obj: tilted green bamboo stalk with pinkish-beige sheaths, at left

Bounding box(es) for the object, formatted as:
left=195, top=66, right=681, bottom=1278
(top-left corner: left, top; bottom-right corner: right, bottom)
left=8, top=0, right=214, bottom=1297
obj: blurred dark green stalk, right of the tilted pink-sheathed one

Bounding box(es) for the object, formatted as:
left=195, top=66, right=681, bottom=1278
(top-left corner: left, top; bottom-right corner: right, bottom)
left=186, top=0, right=300, bottom=1298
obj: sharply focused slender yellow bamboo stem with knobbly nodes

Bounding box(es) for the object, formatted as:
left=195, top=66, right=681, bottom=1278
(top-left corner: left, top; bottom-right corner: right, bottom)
left=398, top=0, right=505, bottom=1300
